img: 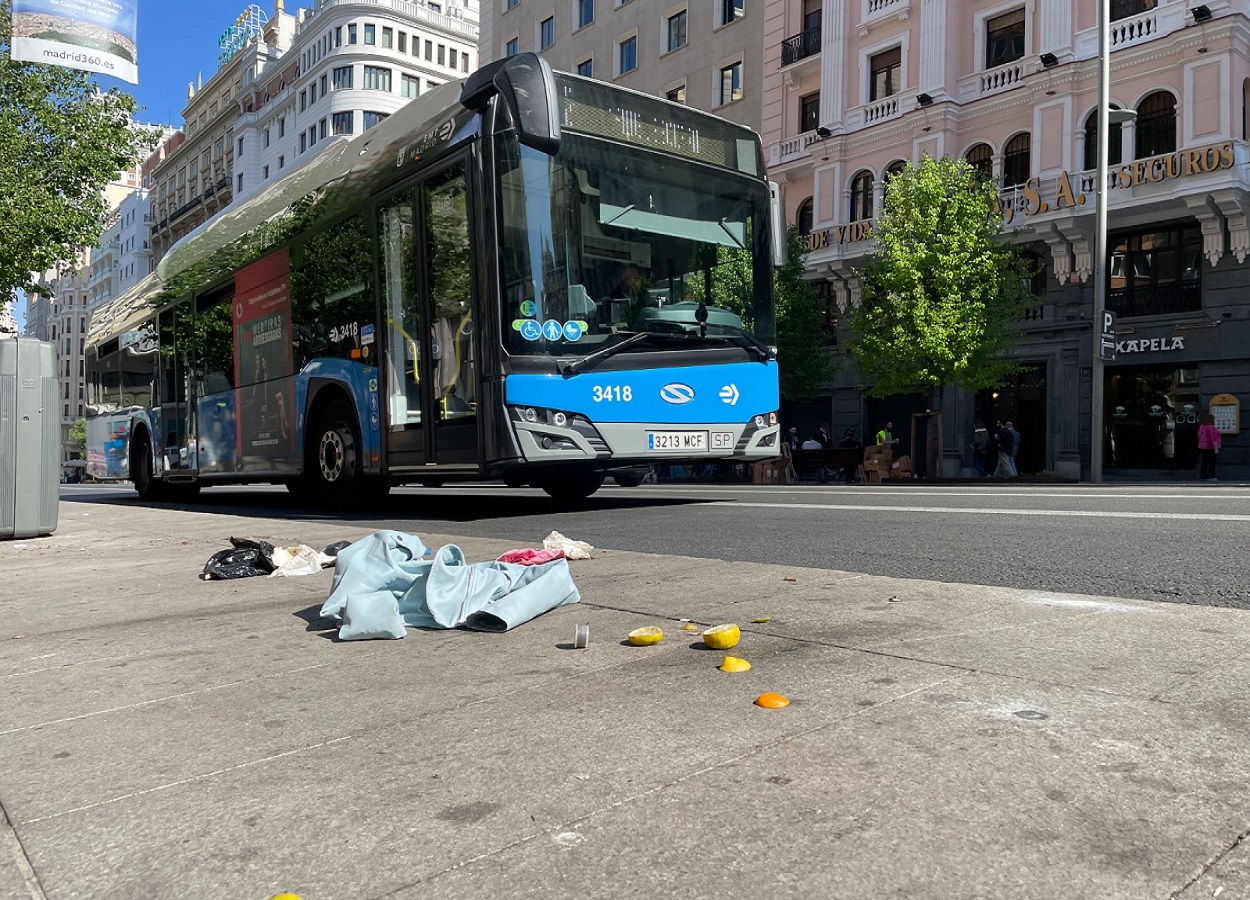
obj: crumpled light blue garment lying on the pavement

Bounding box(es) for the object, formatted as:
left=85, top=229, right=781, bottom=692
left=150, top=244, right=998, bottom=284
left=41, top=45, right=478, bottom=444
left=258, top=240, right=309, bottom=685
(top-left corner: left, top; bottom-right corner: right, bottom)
left=321, top=530, right=581, bottom=640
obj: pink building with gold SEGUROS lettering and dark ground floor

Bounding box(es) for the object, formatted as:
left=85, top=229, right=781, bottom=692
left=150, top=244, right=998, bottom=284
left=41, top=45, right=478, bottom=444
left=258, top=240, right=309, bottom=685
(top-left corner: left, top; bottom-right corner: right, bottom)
left=761, top=0, right=1250, bottom=480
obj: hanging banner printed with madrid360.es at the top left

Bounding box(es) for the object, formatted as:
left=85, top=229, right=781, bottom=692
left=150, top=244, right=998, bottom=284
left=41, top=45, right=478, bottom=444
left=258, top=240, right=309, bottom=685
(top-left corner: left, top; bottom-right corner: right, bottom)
left=10, top=0, right=139, bottom=84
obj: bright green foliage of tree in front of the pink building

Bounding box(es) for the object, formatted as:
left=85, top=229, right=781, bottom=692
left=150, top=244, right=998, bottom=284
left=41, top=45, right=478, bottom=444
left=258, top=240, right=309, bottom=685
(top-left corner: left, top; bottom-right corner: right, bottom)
left=849, top=156, right=1029, bottom=396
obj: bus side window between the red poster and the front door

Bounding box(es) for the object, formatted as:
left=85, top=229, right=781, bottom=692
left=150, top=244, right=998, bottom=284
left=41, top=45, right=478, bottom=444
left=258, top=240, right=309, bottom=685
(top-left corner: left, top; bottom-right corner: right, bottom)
left=291, top=215, right=378, bottom=368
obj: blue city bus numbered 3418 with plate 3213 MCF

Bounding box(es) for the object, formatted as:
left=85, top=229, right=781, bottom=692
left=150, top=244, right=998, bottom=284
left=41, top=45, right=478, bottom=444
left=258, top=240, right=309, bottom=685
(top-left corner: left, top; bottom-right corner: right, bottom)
left=88, top=54, right=783, bottom=501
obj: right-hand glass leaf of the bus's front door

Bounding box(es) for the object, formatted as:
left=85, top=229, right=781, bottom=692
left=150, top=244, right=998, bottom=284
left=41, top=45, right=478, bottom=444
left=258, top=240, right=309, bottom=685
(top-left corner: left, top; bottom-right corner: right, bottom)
left=418, top=163, right=479, bottom=465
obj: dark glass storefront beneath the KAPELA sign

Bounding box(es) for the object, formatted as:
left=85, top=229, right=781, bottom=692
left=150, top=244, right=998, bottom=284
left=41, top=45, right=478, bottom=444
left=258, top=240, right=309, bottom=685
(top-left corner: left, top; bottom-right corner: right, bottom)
left=1103, top=366, right=1201, bottom=473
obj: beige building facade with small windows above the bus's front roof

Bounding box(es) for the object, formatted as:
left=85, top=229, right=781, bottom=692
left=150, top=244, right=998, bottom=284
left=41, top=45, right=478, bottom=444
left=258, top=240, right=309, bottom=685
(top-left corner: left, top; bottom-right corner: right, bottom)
left=481, top=0, right=766, bottom=129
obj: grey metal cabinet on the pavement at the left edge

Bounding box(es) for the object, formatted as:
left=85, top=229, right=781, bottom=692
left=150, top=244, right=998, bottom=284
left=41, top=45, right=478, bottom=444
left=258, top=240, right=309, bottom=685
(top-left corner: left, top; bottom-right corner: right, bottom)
left=0, top=336, right=61, bottom=539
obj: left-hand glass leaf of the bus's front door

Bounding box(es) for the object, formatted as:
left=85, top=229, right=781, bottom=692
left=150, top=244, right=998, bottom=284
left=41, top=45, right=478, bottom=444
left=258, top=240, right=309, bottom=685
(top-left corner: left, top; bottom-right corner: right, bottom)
left=378, top=191, right=428, bottom=466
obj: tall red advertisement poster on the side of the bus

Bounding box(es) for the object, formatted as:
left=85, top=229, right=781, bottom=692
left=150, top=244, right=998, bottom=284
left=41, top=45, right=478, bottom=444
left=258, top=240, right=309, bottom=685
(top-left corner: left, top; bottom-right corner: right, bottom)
left=234, top=250, right=295, bottom=468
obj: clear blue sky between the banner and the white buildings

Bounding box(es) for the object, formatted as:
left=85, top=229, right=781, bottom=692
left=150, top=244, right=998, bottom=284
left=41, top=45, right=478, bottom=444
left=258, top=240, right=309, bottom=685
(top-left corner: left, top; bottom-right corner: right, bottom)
left=18, top=0, right=268, bottom=323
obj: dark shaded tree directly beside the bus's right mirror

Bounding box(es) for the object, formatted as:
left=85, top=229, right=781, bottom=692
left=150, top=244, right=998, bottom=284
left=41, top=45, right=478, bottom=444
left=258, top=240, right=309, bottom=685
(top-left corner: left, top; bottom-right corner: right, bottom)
left=773, top=229, right=835, bottom=401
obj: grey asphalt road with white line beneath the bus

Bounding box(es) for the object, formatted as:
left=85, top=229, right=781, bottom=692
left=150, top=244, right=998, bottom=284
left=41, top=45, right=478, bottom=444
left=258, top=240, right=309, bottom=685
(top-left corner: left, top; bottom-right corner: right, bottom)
left=63, top=484, right=1250, bottom=609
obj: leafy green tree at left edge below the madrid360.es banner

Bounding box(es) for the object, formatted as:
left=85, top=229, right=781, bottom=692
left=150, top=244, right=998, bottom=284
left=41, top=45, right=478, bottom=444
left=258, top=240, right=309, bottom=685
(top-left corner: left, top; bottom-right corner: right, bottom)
left=0, top=0, right=151, bottom=298
